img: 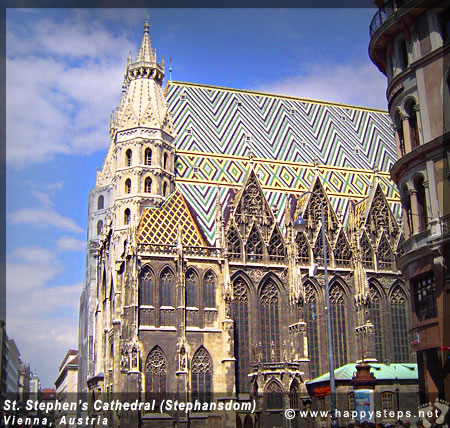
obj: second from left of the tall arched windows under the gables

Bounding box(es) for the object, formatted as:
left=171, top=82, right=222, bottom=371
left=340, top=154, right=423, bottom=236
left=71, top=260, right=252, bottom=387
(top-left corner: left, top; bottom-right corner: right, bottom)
left=260, top=279, right=280, bottom=363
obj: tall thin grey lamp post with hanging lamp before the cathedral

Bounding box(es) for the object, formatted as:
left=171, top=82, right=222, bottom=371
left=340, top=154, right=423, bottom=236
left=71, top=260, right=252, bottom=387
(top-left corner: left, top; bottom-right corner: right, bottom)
left=294, top=191, right=338, bottom=428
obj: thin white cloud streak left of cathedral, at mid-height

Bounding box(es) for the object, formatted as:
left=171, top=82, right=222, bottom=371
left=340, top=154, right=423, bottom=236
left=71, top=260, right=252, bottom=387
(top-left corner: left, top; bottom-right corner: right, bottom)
left=8, top=208, right=83, bottom=233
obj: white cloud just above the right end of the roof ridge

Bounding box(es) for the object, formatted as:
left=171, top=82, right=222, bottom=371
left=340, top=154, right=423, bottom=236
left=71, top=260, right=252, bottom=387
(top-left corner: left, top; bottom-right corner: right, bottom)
left=255, top=63, right=387, bottom=110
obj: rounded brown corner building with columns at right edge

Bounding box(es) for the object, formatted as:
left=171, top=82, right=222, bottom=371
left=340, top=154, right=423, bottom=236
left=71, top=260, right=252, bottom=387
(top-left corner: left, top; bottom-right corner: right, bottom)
left=369, top=0, right=450, bottom=403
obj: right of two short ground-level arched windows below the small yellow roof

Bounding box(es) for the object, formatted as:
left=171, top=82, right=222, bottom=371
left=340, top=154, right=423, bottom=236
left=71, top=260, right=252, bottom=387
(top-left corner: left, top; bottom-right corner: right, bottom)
left=192, top=346, right=212, bottom=403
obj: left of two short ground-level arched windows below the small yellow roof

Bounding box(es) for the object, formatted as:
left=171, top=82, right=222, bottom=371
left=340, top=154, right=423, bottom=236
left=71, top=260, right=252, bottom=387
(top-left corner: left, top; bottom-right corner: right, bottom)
left=145, top=346, right=167, bottom=403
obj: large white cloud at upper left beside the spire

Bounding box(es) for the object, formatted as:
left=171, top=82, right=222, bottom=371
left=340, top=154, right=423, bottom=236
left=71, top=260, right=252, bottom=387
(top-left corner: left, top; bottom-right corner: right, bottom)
left=6, top=13, right=134, bottom=168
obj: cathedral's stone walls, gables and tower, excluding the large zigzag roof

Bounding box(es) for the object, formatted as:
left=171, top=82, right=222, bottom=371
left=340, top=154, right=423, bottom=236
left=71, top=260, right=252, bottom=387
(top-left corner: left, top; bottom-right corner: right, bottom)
left=79, top=18, right=410, bottom=427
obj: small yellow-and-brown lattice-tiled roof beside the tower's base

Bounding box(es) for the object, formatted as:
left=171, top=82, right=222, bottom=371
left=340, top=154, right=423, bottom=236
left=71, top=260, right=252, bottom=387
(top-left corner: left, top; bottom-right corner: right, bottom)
left=138, top=189, right=207, bottom=247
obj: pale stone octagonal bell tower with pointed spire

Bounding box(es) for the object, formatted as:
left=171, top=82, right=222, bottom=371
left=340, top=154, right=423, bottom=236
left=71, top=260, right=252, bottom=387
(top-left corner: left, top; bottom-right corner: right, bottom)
left=97, top=20, right=175, bottom=234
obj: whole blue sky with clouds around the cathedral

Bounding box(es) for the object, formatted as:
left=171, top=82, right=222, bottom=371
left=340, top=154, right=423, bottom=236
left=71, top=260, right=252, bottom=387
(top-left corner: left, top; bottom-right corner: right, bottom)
left=6, top=9, right=386, bottom=387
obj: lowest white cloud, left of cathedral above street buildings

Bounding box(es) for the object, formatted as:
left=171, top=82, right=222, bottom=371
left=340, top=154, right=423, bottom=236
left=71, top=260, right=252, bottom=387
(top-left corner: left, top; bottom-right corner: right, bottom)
left=6, top=247, right=81, bottom=387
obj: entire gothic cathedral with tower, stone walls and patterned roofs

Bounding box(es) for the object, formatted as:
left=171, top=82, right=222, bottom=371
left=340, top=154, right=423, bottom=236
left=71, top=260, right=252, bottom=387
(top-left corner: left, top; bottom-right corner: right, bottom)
left=78, top=22, right=412, bottom=427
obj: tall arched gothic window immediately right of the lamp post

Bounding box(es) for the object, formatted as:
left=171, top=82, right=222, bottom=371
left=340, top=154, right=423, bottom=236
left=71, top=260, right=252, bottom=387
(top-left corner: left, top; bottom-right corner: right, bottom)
left=330, top=284, right=347, bottom=367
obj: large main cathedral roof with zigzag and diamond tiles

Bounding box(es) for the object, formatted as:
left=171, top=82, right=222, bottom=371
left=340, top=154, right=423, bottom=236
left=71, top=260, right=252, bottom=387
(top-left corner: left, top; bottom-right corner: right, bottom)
left=166, top=82, right=399, bottom=242
